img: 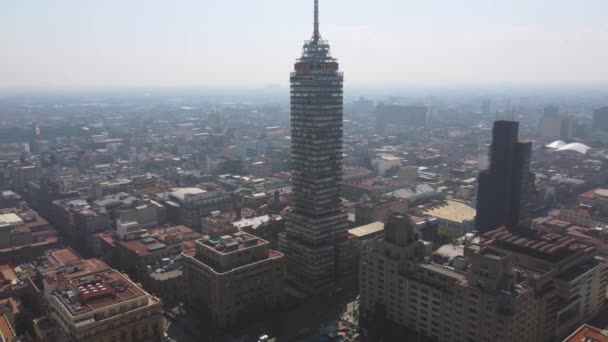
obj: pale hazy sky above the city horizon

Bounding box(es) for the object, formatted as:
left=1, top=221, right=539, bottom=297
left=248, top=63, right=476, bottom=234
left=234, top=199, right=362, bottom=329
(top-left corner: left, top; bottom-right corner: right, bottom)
left=0, top=0, right=608, bottom=89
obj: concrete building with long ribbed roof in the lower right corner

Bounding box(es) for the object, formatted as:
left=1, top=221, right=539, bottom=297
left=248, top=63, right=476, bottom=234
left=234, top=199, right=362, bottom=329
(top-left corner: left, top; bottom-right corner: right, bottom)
left=480, top=227, right=608, bottom=341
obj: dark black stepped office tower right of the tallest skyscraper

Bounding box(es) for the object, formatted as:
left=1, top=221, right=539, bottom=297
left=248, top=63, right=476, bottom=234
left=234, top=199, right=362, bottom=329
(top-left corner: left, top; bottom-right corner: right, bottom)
left=475, top=121, right=534, bottom=232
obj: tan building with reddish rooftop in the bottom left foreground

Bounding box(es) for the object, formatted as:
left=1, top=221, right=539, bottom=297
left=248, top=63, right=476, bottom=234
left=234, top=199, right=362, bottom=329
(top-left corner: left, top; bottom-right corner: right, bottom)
left=34, top=249, right=164, bottom=342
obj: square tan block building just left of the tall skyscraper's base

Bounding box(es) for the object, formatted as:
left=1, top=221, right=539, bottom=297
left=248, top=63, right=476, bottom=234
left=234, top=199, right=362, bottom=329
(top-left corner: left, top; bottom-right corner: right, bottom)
left=183, top=232, right=284, bottom=328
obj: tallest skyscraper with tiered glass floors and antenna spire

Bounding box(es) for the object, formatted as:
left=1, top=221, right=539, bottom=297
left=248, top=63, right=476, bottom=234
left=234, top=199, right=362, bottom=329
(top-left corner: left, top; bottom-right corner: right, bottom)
left=279, top=0, right=347, bottom=293
